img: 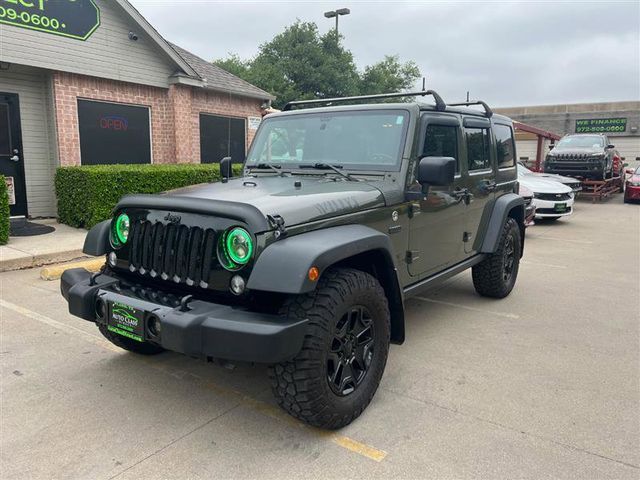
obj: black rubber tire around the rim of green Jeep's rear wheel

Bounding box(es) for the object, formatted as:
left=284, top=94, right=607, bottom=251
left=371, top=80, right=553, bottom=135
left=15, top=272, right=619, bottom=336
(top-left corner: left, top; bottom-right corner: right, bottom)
left=471, top=217, right=522, bottom=298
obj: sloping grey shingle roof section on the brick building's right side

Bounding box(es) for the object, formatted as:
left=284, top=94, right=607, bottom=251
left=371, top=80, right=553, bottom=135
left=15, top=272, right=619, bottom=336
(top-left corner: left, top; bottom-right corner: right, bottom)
left=170, top=43, right=275, bottom=100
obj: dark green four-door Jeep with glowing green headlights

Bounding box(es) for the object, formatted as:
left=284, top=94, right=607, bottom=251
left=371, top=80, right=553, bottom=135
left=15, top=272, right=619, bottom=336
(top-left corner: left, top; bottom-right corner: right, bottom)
left=61, top=90, right=525, bottom=429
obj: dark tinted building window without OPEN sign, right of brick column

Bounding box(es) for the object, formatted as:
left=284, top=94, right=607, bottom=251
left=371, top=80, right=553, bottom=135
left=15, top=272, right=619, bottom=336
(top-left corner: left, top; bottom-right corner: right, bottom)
left=200, top=114, right=246, bottom=163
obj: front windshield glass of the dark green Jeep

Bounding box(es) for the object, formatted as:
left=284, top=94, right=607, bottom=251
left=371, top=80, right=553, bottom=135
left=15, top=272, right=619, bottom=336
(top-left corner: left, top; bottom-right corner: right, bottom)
left=247, top=110, right=409, bottom=171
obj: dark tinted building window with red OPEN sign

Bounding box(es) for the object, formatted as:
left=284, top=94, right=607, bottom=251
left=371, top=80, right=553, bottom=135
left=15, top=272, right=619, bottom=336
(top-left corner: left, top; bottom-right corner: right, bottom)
left=78, top=100, right=151, bottom=165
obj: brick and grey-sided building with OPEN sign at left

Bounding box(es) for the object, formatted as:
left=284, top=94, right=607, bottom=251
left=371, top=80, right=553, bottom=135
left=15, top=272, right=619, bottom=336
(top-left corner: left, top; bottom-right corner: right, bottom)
left=0, top=0, right=272, bottom=217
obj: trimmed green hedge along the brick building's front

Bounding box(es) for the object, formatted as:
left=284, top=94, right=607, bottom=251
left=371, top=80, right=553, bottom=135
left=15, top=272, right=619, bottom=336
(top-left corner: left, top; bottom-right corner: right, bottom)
left=55, top=164, right=242, bottom=228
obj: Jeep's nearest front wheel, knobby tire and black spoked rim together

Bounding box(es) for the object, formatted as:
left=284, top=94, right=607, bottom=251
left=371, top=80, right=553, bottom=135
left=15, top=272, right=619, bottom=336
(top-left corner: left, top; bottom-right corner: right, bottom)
left=269, top=268, right=390, bottom=429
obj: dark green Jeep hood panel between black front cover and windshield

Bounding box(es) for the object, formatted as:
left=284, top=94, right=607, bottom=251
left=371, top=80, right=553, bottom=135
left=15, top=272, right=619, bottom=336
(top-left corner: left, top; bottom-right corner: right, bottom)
left=164, top=175, right=385, bottom=226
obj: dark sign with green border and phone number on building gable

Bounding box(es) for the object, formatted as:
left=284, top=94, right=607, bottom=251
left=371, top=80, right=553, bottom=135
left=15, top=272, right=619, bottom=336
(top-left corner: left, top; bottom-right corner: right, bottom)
left=0, top=0, right=100, bottom=40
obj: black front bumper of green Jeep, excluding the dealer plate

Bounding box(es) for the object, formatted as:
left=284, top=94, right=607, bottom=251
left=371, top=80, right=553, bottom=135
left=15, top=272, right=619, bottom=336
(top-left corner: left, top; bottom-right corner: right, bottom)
left=60, top=268, right=308, bottom=363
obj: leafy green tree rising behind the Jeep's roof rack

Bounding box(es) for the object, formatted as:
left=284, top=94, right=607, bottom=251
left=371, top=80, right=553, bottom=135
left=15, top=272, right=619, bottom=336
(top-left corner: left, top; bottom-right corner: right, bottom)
left=213, top=21, right=420, bottom=108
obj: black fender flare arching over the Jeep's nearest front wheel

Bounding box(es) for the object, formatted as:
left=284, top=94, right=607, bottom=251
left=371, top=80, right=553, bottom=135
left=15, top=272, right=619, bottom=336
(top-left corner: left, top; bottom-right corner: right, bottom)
left=247, top=225, right=404, bottom=343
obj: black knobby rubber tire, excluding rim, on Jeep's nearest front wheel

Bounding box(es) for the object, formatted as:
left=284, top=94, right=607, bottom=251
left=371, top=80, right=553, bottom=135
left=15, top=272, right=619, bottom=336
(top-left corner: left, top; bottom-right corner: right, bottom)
left=269, top=268, right=390, bottom=429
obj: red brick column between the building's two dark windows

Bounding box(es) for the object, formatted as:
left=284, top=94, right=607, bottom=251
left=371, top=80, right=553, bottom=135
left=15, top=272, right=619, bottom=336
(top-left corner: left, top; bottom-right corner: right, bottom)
left=169, top=85, right=195, bottom=163
